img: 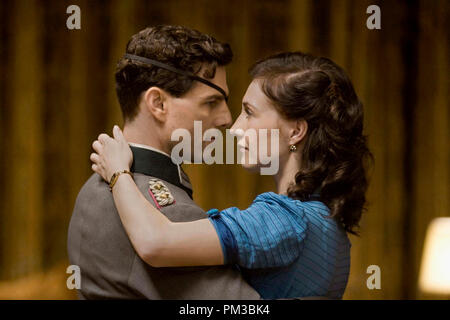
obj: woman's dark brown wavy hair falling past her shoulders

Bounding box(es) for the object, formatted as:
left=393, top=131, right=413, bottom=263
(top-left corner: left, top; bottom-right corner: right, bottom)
left=250, top=52, right=373, bottom=234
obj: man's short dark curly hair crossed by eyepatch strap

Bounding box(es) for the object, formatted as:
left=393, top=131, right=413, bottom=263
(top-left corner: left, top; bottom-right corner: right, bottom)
left=115, top=25, right=233, bottom=121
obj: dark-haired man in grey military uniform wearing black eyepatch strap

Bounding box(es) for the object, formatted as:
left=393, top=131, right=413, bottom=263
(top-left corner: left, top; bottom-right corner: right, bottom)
left=68, top=26, right=259, bottom=299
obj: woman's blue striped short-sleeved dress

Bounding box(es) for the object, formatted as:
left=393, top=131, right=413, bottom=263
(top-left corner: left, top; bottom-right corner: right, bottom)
left=207, top=192, right=351, bottom=299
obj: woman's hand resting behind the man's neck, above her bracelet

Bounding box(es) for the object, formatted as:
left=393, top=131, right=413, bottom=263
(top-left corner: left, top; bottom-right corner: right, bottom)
left=90, top=126, right=133, bottom=182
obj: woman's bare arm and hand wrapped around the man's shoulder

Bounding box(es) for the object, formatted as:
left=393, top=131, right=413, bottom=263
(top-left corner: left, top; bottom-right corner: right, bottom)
left=91, top=126, right=224, bottom=267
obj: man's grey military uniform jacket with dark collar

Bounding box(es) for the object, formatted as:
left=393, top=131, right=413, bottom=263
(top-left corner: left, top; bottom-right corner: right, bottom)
left=67, top=147, right=260, bottom=299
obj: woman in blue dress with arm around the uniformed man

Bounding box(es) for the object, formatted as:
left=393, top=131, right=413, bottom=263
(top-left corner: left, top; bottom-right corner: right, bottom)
left=91, top=52, right=371, bottom=299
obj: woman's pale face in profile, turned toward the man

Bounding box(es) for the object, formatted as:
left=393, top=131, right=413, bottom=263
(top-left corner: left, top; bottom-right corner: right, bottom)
left=231, top=79, right=292, bottom=171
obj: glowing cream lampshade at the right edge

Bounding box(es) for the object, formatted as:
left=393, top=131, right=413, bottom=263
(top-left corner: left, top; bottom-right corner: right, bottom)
left=419, top=218, right=450, bottom=294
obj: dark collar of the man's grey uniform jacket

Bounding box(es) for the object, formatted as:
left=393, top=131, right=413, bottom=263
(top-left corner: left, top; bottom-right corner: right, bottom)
left=129, top=143, right=192, bottom=199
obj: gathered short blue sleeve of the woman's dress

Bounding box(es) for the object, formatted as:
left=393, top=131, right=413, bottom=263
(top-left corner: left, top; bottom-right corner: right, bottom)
left=207, top=196, right=307, bottom=269
